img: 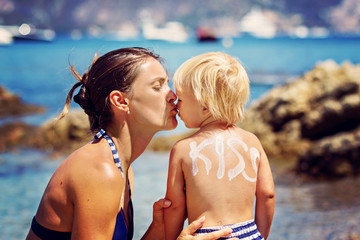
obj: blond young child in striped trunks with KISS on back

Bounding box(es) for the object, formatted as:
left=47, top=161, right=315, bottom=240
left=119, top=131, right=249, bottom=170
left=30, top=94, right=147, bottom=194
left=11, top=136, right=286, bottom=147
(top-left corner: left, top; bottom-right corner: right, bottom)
left=165, top=53, right=275, bottom=240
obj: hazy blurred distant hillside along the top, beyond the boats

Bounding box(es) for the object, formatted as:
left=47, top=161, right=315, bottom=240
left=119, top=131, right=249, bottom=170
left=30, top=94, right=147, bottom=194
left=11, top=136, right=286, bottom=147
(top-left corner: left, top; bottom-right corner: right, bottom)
left=0, top=0, right=360, bottom=34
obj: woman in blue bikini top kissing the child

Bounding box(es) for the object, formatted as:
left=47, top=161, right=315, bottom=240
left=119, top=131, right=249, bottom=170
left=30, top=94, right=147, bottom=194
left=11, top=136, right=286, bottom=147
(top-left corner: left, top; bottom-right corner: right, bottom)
left=27, top=48, right=231, bottom=240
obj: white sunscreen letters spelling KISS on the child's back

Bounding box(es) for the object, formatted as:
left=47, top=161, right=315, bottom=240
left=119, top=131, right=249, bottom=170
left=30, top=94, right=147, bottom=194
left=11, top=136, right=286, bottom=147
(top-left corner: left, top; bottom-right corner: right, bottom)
left=189, top=135, right=260, bottom=182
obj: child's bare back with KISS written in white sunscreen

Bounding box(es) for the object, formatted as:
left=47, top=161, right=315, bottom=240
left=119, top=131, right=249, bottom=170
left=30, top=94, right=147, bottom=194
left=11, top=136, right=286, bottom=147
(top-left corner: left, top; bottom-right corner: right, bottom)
left=176, top=127, right=262, bottom=227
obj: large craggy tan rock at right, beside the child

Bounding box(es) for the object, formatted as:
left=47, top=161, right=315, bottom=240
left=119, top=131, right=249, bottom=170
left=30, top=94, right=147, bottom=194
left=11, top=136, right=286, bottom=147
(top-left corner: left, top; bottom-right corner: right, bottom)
left=239, top=60, right=360, bottom=177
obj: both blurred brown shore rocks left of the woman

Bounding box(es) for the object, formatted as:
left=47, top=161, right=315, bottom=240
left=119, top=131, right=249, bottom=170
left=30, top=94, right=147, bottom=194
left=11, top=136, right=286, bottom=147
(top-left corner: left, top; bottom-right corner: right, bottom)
left=0, top=87, right=92, bottom=155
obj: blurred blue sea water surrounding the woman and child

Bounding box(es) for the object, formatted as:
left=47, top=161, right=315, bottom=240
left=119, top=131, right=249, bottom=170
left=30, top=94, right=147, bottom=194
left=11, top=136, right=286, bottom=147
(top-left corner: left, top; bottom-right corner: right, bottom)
left=0, top=38, right=360, bottom=240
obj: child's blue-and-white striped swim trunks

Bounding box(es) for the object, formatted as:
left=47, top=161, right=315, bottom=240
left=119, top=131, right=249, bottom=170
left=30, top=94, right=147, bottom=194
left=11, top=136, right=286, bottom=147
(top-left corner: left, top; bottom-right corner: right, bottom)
left=194, top=219, right=264, bottom=240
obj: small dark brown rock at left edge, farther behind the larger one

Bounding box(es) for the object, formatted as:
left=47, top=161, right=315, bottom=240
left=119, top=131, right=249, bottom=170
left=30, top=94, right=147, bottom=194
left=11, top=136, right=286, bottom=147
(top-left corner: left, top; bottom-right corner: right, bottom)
left=0, top=86, right=45, bottom=119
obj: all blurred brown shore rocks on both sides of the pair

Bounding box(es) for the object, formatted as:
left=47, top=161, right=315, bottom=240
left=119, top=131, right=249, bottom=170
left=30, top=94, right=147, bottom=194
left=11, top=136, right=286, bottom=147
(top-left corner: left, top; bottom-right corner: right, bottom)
left=0, top=60, right=360, bottom=178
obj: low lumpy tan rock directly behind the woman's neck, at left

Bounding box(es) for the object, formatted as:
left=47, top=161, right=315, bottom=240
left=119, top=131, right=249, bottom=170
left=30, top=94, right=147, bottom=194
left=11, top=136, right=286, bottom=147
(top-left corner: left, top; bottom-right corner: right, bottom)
left=0, top=110, right=93, bottom=156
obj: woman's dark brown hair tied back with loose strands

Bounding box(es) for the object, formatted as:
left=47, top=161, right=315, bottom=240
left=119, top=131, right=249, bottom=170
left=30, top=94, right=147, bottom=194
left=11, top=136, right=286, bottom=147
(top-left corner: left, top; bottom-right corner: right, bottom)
left=59, top=47, right=160, bottom=133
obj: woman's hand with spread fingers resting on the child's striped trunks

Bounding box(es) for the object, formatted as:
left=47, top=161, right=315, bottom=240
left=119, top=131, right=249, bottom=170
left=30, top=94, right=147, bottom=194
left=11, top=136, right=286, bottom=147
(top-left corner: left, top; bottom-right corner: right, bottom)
left=177, top=217, right=235, bottom=240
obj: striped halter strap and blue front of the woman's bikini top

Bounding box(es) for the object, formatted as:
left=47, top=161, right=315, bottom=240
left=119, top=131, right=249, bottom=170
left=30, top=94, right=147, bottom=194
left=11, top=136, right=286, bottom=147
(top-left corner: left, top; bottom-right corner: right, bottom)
left=95, top=129, right=134, bottom=240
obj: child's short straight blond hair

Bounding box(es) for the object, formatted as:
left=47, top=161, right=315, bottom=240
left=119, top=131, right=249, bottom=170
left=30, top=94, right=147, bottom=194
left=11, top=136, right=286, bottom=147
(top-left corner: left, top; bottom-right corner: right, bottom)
left=174, top=52, right=249, bottom=125
